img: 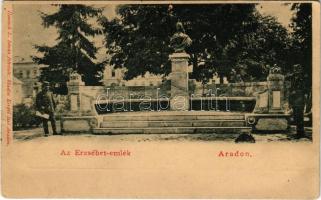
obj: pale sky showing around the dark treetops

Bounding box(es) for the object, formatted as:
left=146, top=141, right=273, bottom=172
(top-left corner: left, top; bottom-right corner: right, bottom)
left=13, top=2, right=293, bottom=62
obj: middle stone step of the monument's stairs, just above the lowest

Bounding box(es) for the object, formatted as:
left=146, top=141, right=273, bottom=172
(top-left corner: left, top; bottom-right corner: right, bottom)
left=100, top=120, right=246, bottom=128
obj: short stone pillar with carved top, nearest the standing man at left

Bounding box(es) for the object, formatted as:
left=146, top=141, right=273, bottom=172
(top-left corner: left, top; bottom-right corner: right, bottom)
left=67, top=73, right=85, bottom=115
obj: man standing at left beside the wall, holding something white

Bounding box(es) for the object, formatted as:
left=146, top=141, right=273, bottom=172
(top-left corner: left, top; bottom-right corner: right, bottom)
left=36, top=81, right=58, bottom=137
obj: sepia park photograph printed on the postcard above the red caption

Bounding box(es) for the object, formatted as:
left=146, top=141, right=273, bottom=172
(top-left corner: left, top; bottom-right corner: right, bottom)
left=13, top=3, right=312, bottom=142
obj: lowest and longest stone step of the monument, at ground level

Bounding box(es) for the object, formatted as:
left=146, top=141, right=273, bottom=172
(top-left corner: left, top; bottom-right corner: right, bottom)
left=93, top=126, right=251, bottom=135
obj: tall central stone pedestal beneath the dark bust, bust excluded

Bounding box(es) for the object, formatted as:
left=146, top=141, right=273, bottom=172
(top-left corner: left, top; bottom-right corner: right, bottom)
left=169, top=52, right=189, bottom=111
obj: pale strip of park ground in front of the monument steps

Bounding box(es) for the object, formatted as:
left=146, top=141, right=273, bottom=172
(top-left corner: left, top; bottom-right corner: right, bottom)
left=14, top=123, right=312, bottom=143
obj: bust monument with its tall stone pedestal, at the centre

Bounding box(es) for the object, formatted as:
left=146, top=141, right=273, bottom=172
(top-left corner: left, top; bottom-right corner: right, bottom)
left=169, top=22, right=192, bottom=111
